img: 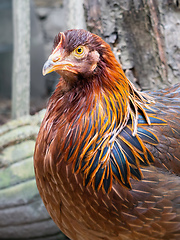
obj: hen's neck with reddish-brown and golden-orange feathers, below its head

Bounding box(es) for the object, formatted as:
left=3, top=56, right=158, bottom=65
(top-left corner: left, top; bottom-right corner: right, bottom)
left=50, top=54, right=150, bottom=134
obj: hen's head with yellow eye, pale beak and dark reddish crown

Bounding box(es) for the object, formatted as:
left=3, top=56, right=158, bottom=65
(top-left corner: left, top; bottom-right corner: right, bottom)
left=43, top=29, right=120, bottom=90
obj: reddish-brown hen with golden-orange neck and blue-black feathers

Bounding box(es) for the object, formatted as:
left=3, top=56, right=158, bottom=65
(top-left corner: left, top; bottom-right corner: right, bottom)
left=34, top=30, right=180, bottom=240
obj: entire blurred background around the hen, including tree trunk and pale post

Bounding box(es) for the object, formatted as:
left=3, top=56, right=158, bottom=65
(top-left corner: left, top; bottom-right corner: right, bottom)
left=0, top=0, right=180, bottom=240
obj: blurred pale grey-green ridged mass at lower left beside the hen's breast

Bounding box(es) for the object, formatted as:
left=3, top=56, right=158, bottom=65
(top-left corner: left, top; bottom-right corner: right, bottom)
left=0, top=110, right=67, bottom=240
